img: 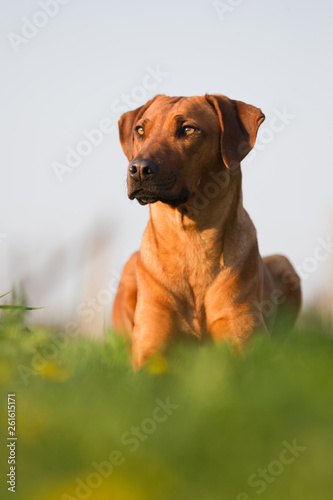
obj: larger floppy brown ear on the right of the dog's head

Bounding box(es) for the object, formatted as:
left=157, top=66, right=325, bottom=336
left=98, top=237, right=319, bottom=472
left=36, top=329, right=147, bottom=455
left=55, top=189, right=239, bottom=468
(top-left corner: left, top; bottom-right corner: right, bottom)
left=205, top=94, right=265, bottom=170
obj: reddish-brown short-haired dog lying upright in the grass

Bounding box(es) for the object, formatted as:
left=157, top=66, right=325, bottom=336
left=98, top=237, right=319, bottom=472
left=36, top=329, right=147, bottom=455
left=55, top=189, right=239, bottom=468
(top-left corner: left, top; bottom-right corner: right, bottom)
left=113, top=95, right=301, bottom=367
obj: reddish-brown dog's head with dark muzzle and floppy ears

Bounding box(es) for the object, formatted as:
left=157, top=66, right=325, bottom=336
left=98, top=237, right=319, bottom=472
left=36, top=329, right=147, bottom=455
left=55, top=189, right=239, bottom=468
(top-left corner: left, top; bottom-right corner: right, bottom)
left=119, top=95, right=265, bottom=207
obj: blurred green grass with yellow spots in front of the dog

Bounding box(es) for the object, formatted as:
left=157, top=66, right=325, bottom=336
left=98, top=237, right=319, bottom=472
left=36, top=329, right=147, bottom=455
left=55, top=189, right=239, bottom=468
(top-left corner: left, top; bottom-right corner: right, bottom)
left=0, top=311, right=333, bottom=500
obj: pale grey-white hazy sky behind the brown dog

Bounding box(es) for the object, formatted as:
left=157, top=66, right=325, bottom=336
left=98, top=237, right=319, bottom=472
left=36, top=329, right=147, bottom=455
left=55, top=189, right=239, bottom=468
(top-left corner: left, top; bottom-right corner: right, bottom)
left=0, top=0, right=333, bottom=326
